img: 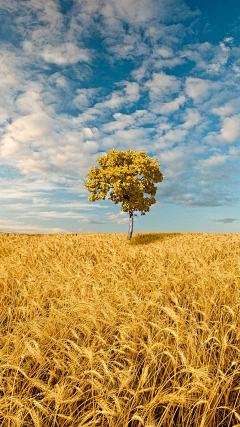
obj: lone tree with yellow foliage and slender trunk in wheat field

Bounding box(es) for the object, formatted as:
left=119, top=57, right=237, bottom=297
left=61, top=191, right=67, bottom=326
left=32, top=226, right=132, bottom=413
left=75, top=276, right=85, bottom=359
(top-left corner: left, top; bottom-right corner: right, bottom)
left=84, top=148, right=164, bottom=239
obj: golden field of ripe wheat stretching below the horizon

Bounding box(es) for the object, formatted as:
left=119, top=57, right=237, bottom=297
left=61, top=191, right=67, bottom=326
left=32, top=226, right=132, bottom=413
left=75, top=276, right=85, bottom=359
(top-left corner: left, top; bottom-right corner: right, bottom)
left=0, top=233, right=240, bottom=427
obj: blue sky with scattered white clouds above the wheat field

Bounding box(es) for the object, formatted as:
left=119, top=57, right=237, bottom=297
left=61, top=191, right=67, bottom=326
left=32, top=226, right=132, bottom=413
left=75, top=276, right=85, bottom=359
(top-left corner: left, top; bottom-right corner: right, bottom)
left=0, top=0, right=240, bottom=234
